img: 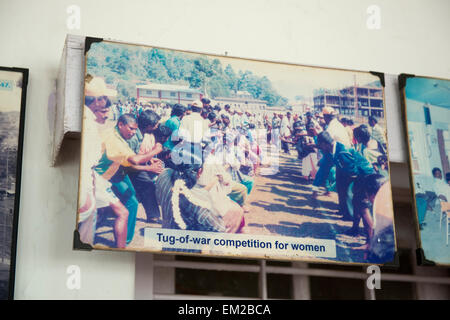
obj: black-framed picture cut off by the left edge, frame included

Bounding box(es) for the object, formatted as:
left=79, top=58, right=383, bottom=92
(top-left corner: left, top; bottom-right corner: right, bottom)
left=0, top=67, right=28, bottom=300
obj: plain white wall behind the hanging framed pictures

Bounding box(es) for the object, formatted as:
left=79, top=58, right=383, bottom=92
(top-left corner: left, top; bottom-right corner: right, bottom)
left=0, top=0, right=450, bottom=299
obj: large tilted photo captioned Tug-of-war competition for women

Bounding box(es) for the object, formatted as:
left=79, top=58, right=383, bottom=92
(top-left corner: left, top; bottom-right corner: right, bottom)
left=74, top=38, right=396, bottom=264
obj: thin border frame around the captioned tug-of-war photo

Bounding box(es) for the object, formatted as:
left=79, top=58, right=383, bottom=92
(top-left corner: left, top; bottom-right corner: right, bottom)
left=73, top=37, right=398, bottom=266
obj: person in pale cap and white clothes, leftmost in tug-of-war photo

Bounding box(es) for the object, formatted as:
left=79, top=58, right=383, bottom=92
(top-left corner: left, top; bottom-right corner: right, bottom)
left=78, top=76, right=129, bottom=248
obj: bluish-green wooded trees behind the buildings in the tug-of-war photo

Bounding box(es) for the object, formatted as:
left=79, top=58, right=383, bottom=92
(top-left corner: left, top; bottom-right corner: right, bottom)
left=87, top=42, right=287, bottom=106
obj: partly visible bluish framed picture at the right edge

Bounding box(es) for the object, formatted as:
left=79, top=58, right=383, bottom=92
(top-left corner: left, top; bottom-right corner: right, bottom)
left=399, top=75, right=450, bottom=265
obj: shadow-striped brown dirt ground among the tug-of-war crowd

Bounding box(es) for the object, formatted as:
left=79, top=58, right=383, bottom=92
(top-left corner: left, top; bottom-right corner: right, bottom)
left=96, top=150, right=365, bottom=262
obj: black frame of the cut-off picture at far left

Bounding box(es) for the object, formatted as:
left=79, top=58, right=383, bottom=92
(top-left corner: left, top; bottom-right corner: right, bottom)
left=0, top=67, right=29, bottom=300
